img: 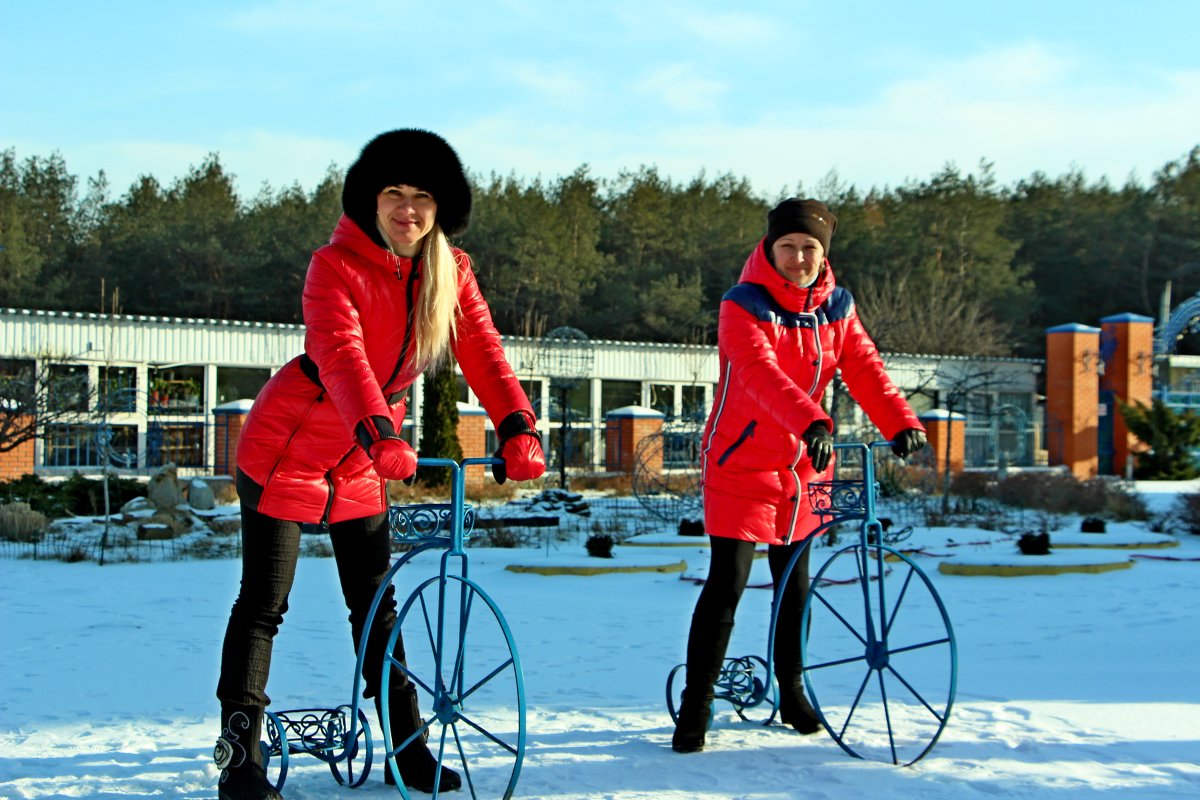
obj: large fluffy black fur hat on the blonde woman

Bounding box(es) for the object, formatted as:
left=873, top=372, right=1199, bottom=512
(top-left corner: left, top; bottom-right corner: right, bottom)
left=342, top=128, right=470, bottom=246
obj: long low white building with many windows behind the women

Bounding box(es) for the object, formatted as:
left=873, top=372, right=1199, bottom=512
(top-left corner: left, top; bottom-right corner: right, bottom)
left=0, top=308, right=1043, bottom=475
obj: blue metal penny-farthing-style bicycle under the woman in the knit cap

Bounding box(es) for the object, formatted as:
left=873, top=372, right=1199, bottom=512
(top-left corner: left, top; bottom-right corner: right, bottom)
left=667, top=441, right=958, bottom=765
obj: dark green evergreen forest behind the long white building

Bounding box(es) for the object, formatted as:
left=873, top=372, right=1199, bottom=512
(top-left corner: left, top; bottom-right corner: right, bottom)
left=0, top=146, right=1200, bottom=356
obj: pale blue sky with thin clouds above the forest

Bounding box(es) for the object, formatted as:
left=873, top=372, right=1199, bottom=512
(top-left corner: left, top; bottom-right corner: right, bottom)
left=0, top=0, right=1200, bottom=198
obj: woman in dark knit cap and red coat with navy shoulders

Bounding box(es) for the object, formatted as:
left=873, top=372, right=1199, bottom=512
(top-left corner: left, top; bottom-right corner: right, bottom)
left=671, top=198, right=925, bottom=753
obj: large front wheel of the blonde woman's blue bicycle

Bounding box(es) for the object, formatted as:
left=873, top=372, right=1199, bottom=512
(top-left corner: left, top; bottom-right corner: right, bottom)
left=382, top=576, right=526, bottom=798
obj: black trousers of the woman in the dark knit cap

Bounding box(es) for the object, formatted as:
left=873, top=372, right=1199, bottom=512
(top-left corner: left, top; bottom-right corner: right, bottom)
left=691, top=535, right=811, bottom=682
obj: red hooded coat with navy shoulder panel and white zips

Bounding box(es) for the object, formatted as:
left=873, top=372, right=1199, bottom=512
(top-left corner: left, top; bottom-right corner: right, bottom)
left=701, top=242, right=924, bottom=545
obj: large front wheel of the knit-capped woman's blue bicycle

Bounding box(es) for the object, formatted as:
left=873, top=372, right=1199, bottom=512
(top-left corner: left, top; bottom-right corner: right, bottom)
left=800, top=543, right=958, bottom=764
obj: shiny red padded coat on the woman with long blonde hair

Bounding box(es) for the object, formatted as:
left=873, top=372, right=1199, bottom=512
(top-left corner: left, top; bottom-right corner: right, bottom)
left=238, top=216, right=533, bottom=523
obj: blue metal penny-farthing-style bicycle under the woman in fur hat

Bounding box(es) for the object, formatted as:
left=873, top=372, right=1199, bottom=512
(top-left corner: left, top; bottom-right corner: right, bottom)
left=262, top=458, right=526, bottom=800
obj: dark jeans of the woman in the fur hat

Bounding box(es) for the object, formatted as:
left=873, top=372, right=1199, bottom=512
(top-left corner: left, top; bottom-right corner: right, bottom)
left=217, top=505, right=404, bottom=710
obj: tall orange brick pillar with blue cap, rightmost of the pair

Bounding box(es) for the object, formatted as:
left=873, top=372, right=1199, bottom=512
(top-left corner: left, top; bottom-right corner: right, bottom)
left=1100, top=314, right=1154, bottom=475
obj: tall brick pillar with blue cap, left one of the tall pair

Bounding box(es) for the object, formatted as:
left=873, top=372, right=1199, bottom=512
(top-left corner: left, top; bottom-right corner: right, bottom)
left=1045, top=324, right=1100, bottom=480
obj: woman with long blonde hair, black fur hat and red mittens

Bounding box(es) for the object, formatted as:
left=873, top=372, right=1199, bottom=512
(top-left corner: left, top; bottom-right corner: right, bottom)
left=215, top=128, right=545, bottom=800
